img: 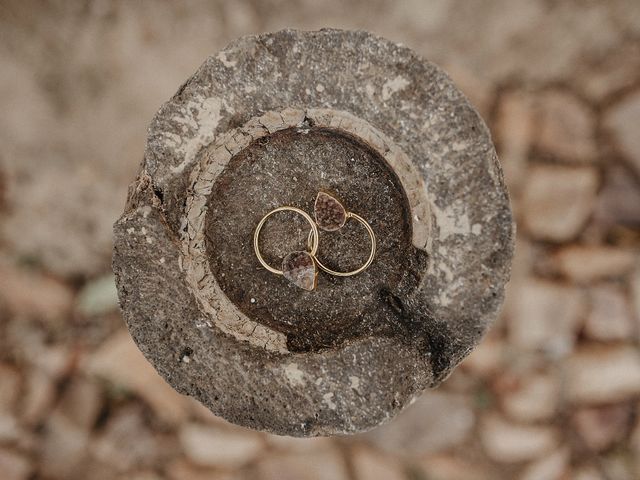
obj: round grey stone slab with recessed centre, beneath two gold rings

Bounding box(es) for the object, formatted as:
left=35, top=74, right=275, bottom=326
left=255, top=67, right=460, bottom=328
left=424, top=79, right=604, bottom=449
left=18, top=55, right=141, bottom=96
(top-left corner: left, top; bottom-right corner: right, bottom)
left=113, top=30, right=514, bottom=436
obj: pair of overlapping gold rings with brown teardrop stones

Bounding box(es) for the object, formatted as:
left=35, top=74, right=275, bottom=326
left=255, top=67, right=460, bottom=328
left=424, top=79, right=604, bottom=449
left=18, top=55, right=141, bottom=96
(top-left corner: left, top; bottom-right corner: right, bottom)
left=253, top=192, right=376, bottom=290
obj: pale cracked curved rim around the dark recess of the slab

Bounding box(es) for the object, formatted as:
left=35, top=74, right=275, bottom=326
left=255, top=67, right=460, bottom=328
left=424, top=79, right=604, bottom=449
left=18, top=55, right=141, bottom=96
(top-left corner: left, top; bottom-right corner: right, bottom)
left=180, top=108, right=431, bottom=354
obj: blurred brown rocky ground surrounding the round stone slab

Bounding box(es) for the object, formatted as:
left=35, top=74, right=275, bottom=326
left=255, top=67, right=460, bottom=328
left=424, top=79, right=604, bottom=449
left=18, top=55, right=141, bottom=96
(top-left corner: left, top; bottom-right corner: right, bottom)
left=0, top=0, right=640, bottom=480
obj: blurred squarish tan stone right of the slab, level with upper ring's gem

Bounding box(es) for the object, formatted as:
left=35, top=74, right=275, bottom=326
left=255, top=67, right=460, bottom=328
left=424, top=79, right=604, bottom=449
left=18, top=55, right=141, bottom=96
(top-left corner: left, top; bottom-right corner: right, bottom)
left=522, top=165, right=598, bottom=242
